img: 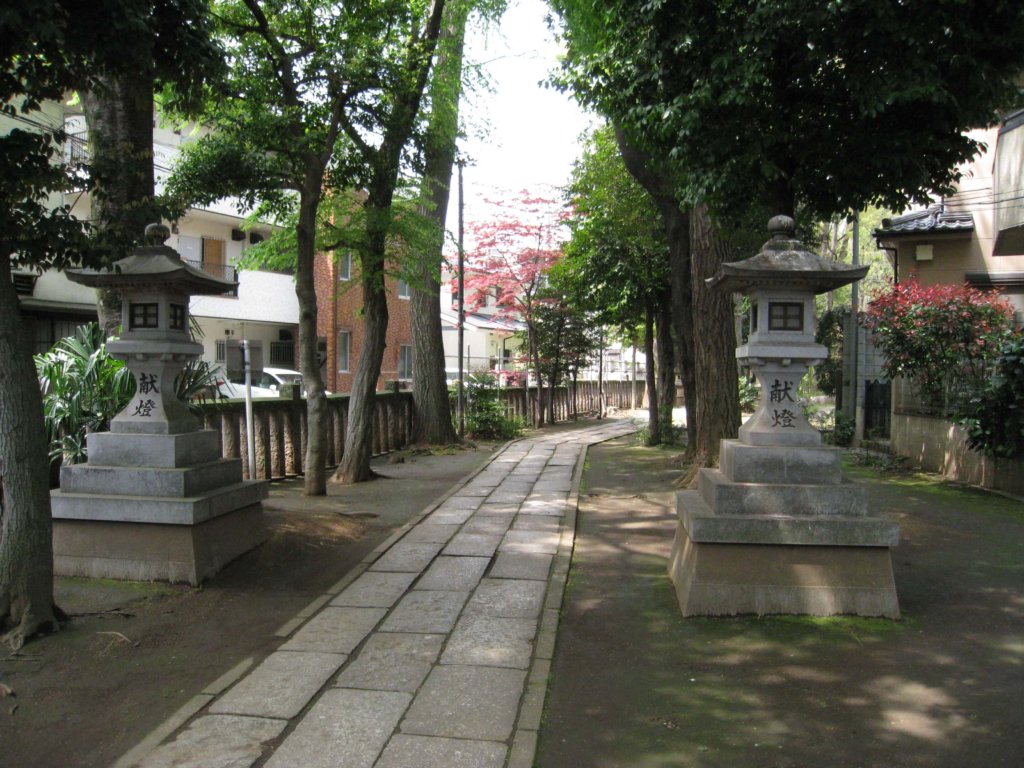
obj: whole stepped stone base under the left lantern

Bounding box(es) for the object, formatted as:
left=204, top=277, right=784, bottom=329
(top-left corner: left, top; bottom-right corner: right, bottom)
left=50, top=430, right=267, bottom=585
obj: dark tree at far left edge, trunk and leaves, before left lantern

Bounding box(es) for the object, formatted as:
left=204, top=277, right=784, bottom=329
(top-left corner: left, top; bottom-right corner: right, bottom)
left=0, top=0, right=211, bottom=647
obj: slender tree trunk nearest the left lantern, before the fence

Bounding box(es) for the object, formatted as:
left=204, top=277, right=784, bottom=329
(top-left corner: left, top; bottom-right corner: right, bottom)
left=295, top=167, right=327, bottom=496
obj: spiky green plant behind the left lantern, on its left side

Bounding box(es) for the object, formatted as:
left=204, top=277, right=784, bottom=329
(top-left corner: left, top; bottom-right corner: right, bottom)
left=36, top=323, right=135, bottom=464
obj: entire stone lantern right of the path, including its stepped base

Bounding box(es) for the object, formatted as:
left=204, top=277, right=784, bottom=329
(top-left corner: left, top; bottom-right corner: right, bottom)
left=669, top=216, right=899, bottom=617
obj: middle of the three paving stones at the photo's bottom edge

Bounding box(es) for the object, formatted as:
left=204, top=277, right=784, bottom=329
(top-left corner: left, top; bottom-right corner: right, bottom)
left=266, top=688, right=412, bottom=768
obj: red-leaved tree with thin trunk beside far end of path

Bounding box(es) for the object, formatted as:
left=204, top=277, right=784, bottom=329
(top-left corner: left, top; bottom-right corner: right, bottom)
left=464, top=190, right=565, bottom=426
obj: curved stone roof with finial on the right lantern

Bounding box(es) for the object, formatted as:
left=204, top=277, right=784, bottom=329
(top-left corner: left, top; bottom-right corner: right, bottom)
left=708, top=216, right=868, bottom=294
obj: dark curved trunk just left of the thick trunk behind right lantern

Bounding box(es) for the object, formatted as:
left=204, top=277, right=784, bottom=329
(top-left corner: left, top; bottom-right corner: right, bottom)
left=615, top=125, right=699, bottom=455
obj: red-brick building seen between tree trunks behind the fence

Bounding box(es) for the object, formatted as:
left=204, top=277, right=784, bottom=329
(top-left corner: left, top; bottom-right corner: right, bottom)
left=313, top=252, right=413, bottom=392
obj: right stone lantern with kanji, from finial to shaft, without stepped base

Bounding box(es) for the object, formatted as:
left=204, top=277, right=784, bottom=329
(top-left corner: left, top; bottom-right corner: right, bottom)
left=711, top=216, right=867, bottom=446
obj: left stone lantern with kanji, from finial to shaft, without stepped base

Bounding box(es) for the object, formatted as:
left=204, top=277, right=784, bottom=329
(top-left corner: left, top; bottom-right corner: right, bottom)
left=68, top=224, right=236, bottom=434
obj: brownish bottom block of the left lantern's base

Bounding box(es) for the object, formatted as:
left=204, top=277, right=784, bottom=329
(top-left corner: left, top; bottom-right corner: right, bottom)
left=53, top=503, right=267, bottom=586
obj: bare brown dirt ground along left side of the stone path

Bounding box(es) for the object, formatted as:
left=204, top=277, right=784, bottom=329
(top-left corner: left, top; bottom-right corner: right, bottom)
left=0, top=444, right=495, bottom=768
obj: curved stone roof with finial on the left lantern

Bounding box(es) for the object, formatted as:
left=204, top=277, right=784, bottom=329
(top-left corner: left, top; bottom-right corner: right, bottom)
left=67, top=224, right=238, bottom=295
